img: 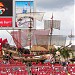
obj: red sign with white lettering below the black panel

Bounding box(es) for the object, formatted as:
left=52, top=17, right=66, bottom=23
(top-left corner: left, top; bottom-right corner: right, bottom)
left=0, top=18, right=12, bottom=27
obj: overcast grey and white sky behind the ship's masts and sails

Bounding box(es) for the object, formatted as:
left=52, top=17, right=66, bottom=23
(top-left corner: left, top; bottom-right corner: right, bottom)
left=0, top=0, right=75, bottom=44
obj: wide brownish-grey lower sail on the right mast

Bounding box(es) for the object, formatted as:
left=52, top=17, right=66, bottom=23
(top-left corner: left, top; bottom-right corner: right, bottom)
left=36, top=35, right=66, bottom=46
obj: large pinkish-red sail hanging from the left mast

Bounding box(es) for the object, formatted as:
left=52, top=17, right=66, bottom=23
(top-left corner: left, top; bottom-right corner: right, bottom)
left=11, top=29, right=49, bottom=47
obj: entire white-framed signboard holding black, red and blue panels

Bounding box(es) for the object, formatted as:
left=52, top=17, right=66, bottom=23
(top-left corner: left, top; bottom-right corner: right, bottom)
left=0, top=0, right=36, bottom=29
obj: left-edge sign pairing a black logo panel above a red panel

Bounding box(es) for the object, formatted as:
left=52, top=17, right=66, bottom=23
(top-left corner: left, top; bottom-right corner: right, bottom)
left=0, top=0, right=13, bottom=27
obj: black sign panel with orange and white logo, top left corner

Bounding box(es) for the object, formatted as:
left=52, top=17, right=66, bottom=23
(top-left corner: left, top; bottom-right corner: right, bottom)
left=0, top=0, right=13, bottom=17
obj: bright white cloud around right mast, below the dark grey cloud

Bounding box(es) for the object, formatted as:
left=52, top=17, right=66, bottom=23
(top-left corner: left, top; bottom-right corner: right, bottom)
left=37, top=5, right=74, bottom=35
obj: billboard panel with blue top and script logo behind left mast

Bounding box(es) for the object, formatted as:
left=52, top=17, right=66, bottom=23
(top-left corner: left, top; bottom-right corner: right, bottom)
left=15, top=1, right=34, bottom=28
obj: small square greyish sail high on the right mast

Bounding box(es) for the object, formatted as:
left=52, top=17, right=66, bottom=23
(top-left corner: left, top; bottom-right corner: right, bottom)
left=44, top=20, right=60, bottom=30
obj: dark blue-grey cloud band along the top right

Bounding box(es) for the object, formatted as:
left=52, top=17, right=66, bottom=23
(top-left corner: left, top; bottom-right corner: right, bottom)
left=36, top=0, right=74, bottom=10
